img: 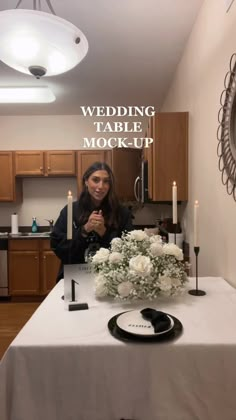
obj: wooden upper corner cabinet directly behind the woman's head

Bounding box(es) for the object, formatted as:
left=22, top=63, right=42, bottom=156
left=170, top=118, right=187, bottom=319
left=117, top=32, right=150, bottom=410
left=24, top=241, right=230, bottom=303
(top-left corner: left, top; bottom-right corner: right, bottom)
left=77, top=148, right=141, bottom=201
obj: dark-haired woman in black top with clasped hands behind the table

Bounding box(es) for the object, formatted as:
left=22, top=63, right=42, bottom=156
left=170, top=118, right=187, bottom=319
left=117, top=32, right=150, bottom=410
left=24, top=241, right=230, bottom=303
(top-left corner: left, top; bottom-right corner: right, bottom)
left=51, top=162, right=133, bottom=280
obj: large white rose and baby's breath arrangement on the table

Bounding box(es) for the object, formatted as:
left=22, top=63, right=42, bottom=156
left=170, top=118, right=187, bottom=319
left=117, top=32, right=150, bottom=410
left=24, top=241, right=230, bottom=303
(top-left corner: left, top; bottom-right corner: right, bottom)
left=91, top=230, right=187, bottom=300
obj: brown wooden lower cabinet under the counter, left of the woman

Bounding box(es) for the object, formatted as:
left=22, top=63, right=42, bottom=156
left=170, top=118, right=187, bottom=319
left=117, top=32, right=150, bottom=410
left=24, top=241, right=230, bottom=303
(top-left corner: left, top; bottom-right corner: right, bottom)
left=8, top=239, right=60, bottom=296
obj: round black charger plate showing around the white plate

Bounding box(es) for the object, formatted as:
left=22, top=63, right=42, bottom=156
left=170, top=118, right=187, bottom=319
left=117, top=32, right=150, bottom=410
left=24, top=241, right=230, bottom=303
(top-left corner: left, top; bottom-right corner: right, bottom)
left=107, top=311, right=183, bottom=343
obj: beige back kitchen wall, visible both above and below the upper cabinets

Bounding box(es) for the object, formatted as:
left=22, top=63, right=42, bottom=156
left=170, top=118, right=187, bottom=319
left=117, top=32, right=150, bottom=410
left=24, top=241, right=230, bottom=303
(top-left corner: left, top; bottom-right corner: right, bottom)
left=0, top=115, right=171, bottom=226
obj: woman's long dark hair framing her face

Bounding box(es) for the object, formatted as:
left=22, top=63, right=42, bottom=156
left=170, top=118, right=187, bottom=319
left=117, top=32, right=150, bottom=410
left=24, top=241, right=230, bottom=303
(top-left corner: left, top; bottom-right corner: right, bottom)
left=78, top=162, right=119, bottom=227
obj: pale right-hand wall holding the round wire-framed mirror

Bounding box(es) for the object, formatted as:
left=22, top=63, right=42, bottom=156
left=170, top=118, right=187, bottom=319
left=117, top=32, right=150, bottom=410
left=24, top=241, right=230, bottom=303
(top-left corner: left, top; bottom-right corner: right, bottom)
left=162, top=0, right=236, bottom=288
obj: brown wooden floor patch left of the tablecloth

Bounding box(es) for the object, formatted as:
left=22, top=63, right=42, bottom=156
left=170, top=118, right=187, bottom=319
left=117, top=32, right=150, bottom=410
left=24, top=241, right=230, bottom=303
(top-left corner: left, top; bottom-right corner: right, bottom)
left=0, top=302, right=40, bottom=359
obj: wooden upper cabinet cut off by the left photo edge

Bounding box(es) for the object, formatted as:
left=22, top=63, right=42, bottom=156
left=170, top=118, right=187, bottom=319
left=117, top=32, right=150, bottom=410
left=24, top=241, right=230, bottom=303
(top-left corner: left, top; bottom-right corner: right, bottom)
left=0, top=151, right=22, bottom=202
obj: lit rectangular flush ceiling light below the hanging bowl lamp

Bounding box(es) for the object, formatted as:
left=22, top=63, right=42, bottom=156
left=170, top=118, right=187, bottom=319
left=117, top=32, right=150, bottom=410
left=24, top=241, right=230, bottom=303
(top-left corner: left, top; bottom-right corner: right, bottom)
left=0, top=86, right=56, bottom=104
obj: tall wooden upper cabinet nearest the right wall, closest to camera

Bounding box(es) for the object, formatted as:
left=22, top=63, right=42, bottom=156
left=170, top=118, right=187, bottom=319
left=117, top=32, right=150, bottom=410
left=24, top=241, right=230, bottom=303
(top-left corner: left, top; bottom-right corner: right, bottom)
left=143, top=112, right=188, bottom=201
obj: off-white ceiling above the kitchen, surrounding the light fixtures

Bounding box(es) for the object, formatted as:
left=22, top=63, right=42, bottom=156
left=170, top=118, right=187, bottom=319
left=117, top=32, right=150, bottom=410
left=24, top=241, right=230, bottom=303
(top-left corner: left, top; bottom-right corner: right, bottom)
left=0, top=0, right=203, bottom=115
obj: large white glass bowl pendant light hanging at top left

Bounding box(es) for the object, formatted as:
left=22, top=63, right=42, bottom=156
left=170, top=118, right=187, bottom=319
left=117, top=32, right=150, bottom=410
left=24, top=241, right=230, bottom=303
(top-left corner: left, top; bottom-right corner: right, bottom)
left=0, top=0, right=88, bottom=78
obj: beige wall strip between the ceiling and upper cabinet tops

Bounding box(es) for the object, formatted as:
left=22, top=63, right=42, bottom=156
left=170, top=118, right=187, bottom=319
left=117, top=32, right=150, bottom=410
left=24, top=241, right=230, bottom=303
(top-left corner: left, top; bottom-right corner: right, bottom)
left=0, top=115, right=147, bottom=150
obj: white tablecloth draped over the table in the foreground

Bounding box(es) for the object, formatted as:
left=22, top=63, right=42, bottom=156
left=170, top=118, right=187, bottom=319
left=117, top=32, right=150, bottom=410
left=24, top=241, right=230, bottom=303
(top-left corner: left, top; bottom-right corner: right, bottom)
left=0, top=277, right=236, bottom=420
